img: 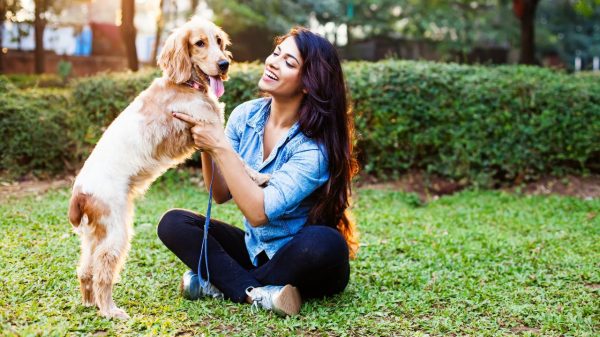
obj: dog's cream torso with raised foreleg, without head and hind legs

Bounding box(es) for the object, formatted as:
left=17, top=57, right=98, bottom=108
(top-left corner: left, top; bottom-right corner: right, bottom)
left=75, top=78, right=223, bottom=197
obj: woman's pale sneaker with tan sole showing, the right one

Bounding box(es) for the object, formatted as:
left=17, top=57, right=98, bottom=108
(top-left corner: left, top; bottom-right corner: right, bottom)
left=246, top=284, right=302, bottom=316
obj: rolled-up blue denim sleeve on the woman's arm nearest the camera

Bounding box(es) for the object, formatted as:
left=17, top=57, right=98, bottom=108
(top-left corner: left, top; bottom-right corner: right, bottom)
left=263, top=146, right=329, bottom=221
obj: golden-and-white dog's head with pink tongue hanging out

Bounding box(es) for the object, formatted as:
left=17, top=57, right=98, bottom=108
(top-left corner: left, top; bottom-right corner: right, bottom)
left=158, top=18, right=231, bottom=96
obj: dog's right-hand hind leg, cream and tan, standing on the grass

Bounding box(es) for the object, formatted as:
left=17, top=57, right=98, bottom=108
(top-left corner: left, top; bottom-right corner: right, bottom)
left=93, top=214, right=130, bottom=319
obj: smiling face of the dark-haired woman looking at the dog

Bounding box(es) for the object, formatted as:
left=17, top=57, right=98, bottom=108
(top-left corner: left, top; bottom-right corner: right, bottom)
left=258, top=36, right=303, bottom=97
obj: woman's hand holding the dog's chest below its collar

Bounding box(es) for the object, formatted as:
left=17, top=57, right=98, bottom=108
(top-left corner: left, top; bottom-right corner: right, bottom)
left=172, top=112, right=227, bottom=154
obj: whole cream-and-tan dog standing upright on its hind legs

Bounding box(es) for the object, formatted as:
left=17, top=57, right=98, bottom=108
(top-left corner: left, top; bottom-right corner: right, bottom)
left=68, top=18, right=268, bottom=319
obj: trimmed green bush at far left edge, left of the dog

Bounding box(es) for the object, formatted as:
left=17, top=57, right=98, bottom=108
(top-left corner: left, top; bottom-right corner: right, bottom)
left=0, top=87, right=73, bottom=177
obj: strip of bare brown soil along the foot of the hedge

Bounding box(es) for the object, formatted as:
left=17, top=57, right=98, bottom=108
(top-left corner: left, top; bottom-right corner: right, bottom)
left=0, top=172, right=600, bottom=202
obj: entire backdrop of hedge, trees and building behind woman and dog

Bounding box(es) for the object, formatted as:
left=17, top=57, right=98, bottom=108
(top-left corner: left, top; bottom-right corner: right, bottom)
left=0, top=0, right=600, bottom=186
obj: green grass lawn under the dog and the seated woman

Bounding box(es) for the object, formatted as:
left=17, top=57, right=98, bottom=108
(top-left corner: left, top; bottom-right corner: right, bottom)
left=0, top=175, right=600, bottom=336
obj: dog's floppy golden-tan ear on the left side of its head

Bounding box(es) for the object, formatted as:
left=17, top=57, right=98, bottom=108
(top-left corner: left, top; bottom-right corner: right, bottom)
left=157, top=28, right=192, bottom=83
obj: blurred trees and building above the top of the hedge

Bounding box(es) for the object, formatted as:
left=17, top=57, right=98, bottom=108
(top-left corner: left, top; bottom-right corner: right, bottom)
left=0, top=0, right=600, bottom=76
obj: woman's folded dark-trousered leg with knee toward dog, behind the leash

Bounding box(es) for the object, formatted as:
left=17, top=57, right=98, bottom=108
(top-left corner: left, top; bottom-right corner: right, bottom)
left=157, top=209, right=261, bottom=303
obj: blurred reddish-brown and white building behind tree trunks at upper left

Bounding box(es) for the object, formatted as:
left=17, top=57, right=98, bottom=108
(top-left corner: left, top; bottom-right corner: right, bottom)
left=1, top=0, right=159, bottom=75
